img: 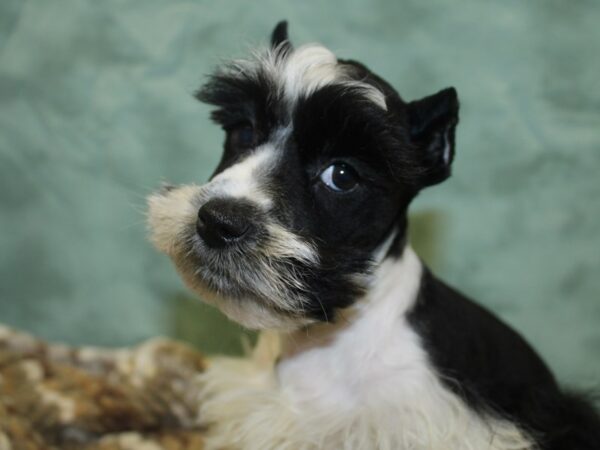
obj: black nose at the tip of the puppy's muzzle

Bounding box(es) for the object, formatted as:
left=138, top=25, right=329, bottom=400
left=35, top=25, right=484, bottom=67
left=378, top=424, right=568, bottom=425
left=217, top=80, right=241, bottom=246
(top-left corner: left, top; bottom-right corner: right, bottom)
left=196, top=198, right=254, bottom=248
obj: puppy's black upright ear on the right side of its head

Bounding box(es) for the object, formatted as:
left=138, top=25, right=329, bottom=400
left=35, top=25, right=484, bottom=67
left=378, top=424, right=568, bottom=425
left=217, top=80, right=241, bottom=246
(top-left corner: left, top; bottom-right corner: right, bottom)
left=408, top=87, right=458, bottom=187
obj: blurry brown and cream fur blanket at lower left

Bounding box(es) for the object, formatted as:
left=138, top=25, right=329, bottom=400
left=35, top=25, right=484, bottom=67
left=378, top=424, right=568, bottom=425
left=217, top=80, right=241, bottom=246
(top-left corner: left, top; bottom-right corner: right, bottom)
left=0, top=326, right=204, bottom=450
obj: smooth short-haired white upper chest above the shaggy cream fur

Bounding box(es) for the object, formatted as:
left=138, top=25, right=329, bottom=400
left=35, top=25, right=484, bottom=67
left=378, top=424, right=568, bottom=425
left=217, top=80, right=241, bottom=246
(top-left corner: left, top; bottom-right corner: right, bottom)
left=277, top=319, right=432, bottom=414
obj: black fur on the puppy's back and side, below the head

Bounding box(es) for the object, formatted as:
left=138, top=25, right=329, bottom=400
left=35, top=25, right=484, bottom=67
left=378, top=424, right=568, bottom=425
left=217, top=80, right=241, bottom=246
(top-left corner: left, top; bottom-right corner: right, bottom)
left=409, top=271, right=600, bottom=450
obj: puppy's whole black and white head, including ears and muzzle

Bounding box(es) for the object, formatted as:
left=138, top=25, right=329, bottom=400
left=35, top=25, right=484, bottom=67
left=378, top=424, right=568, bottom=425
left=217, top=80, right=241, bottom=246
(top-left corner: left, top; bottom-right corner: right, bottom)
left=149, top=23, right=458, bottom=328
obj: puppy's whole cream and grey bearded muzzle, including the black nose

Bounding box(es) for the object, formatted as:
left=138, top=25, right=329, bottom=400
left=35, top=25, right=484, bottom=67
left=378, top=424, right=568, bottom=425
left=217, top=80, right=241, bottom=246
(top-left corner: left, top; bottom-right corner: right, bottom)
left=148, top=186, right=318, bottom=328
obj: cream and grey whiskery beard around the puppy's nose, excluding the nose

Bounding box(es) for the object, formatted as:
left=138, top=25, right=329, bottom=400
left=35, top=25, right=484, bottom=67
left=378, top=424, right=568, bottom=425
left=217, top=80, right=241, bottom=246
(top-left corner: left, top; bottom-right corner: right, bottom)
left=148, top=183, right=318, bottom=329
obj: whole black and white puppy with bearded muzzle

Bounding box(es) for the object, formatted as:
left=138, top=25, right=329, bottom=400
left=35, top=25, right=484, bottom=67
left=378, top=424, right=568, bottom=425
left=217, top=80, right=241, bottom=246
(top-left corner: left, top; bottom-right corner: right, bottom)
left=149, top=22, right=600, bottom=450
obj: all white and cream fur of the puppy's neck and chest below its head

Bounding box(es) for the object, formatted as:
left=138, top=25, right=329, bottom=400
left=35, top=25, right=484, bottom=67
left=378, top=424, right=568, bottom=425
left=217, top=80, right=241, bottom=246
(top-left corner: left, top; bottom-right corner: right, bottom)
left=200, top=248, right=531, bottom=450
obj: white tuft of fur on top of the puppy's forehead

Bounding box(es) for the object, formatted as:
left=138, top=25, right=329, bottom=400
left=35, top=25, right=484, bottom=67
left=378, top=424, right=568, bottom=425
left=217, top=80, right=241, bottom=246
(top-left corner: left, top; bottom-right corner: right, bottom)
left=233, top=44, right=387, bottom=110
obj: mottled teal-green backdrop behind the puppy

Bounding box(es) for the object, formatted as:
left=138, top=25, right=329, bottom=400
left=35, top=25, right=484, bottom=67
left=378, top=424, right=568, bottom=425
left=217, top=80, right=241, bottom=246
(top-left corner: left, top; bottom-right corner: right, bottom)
left=0, top=0, right=600, bottom=387
